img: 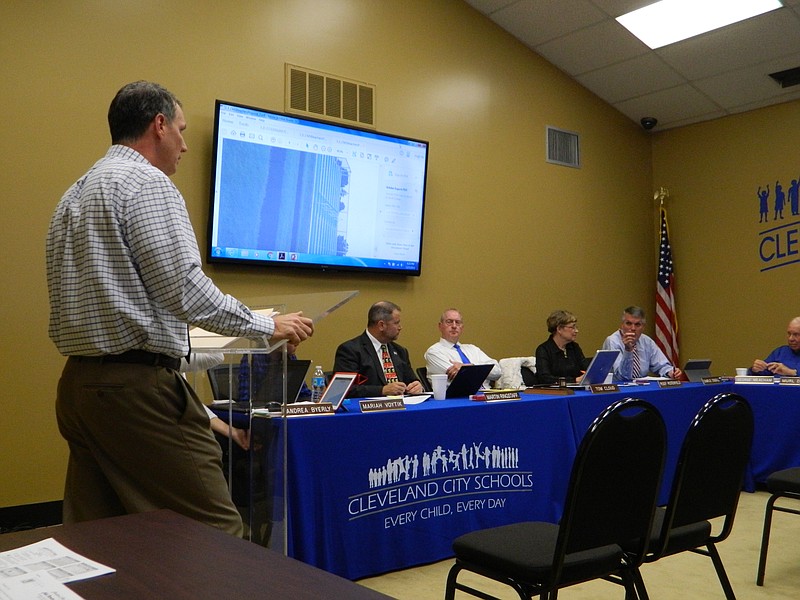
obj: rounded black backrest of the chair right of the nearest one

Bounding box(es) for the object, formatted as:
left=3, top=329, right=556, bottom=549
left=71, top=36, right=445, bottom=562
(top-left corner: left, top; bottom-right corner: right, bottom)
left=653, top=393, right=753, bottom=551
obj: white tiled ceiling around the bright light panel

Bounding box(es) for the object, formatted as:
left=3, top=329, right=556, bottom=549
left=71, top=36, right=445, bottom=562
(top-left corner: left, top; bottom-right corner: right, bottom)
left=465, top=0, right=800, bottom=131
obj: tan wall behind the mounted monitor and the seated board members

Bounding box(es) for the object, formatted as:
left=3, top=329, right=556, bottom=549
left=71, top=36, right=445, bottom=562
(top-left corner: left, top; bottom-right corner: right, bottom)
left=0, top=0, right=656, bottom=506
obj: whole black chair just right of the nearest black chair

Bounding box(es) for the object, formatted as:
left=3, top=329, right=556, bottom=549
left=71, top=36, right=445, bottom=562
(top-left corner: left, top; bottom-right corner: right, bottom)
left=635, top=394, right=753, bottom=600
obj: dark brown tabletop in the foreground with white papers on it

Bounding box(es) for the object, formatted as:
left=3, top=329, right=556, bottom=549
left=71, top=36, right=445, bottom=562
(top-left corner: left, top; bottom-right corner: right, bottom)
left=0, top=510, right=389, bottom=600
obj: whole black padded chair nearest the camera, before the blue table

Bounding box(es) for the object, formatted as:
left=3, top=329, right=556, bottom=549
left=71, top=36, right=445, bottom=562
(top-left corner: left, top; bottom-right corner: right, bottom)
left=445, top=398, right=666, bottom=600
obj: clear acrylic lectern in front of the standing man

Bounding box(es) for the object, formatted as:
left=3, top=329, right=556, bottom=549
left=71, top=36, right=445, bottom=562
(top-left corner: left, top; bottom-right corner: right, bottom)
left=186, top=291, right=358, bottom=554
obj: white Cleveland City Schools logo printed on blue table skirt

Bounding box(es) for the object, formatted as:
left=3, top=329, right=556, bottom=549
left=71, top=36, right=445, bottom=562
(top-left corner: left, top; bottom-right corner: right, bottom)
left=347, top=442, right=533, bottom=529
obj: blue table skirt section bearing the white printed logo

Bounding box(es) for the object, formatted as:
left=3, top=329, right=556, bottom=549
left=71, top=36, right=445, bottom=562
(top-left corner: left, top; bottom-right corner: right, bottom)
left=288, top=397, right=576, bottom=579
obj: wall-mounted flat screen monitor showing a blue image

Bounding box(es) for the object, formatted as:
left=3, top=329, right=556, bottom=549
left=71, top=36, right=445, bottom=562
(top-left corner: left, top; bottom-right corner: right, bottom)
left=207, top=100, right=428, bottom=275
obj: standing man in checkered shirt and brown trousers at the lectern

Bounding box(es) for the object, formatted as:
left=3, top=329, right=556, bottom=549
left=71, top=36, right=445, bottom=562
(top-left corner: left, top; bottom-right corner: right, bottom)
left=46, top=81, right=313, bottom=535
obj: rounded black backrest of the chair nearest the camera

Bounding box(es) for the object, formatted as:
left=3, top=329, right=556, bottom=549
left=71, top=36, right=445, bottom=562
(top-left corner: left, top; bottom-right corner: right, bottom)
left=554, top=398, right=667, bottom=580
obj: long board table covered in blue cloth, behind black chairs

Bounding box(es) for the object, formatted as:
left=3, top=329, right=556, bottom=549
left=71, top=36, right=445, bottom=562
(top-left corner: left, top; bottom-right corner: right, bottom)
left=273, top=382, right=800, bottom=579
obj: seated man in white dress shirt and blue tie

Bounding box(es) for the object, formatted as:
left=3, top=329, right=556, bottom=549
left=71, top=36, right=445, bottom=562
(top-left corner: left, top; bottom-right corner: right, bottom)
left=425, top=308, right=502, bottom=388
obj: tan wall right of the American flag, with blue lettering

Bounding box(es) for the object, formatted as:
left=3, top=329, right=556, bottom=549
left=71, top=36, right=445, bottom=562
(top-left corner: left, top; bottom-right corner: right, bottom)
left=653, top=102, right=800, bottom=374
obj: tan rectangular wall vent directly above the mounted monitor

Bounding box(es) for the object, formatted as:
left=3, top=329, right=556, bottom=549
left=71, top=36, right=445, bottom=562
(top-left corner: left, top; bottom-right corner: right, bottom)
left=284, top=63, right=376, bottom=129
